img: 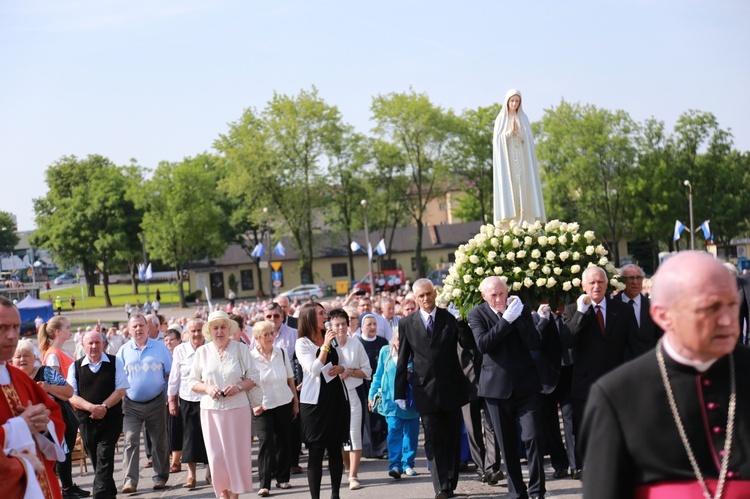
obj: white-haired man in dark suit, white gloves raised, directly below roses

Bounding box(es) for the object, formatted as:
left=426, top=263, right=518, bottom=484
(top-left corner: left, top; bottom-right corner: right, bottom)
left=469, top=276, right=545, bottom=499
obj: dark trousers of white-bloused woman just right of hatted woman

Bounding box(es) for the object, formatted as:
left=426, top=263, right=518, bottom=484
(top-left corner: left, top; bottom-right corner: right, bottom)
left=253, top=402, right=292, bottom=489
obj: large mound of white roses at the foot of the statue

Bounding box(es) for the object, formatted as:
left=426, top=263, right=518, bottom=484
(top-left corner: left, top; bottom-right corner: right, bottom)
left=438, top=220, right=624, bottom=319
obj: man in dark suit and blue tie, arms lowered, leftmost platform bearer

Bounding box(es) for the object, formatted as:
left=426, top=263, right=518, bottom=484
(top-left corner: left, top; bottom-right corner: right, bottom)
left=394, top=279, right=470, bottom=499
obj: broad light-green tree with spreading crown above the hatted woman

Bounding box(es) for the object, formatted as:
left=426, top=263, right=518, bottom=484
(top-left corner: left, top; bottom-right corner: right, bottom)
left=214, top=87, right=343, bottom=283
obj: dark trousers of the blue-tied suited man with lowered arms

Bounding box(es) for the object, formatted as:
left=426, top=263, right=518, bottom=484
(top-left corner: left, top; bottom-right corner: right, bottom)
left=422, top=409, right=461, bottom=494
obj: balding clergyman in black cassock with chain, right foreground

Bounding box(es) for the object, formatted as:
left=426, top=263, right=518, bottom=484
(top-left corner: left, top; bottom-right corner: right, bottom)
left=580, top=251, right=750, bottom=499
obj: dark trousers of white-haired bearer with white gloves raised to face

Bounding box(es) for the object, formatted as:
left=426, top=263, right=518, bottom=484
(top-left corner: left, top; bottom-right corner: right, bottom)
left=485, top=393, right=545, bottom=499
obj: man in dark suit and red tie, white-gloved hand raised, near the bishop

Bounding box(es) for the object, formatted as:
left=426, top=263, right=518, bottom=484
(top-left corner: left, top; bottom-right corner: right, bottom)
left=561, top=266, right=638, bottom=478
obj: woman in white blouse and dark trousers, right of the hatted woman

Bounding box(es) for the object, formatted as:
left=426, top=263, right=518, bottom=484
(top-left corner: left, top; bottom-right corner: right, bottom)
left=250, top=321, right=299, bottom=497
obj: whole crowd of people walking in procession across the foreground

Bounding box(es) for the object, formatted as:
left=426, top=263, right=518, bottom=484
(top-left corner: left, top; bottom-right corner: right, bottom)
left=0, top=252, right=750, bottom=499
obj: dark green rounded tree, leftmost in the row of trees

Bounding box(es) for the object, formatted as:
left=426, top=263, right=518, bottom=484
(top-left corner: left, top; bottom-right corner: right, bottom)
left=31, top=155, right=140, bottom=307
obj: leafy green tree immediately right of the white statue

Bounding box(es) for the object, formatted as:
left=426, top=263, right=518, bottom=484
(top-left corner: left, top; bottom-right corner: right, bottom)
left=535, top=101, right=637, bottom=264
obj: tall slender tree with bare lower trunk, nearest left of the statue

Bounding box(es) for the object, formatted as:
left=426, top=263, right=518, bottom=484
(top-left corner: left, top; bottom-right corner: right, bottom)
left=370, top=89, right=455, bottom=277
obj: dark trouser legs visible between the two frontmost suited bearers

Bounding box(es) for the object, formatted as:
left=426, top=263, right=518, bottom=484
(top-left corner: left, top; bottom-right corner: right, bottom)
left=461, top=397, right=501, bottom=473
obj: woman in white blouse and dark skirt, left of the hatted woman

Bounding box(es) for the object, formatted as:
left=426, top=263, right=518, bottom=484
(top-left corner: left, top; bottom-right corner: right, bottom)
left=167, top=319, right=211, bottom=489
